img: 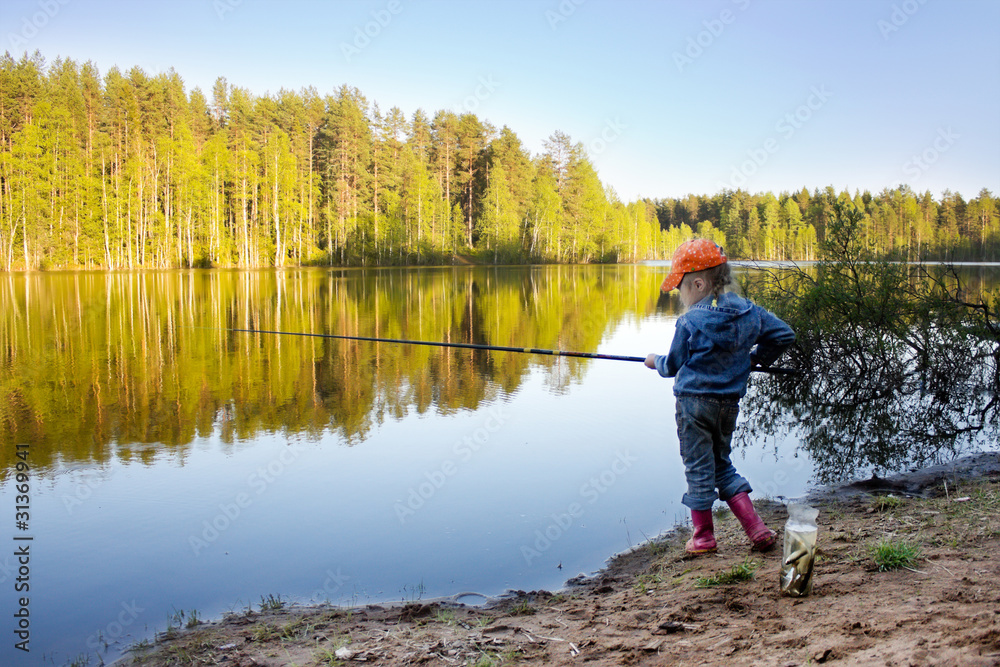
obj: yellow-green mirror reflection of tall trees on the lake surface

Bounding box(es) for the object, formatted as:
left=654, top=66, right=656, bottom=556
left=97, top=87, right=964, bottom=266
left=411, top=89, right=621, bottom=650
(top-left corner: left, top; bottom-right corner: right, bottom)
left=0, top=266, right=661, bottom=467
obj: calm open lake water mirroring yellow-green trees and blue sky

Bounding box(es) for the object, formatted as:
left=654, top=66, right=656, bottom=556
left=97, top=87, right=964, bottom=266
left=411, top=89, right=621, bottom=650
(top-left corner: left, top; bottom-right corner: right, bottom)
left=0, top=265, right=992, bottom=665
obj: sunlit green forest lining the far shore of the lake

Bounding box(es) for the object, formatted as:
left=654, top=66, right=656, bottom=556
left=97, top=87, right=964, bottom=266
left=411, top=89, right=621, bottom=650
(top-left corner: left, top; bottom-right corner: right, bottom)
left=0, top=52, right=1000, bottom=271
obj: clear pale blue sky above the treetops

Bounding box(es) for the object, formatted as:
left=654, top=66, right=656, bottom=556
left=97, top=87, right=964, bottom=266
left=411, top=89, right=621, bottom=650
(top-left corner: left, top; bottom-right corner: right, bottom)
left=0, top=0, right=1000, bottom=201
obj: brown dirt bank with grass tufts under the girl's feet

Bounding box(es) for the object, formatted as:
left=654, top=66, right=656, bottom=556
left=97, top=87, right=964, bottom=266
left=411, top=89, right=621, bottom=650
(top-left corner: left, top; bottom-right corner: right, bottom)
left=122, top=454, right=1000, bottom=667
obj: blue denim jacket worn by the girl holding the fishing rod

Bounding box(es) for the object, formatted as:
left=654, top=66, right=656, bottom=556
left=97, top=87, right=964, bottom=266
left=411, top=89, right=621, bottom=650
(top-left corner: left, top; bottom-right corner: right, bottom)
left=656, top=292, right=795, bottom=399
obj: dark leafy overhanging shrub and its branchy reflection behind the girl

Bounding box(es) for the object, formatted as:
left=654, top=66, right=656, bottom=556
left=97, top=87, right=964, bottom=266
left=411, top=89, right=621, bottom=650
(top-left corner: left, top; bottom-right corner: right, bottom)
left=742, top=208, right=1000, bottom=481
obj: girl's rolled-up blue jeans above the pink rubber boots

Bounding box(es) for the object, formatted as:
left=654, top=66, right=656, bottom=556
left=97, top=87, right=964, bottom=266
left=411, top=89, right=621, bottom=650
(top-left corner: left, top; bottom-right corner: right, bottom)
left=675, top=396, right=752, bottom=510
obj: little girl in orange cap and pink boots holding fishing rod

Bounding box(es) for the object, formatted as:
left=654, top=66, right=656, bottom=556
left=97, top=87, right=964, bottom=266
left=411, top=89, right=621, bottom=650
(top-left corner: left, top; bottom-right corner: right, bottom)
left=646, top=239, right=795, bottom=554
